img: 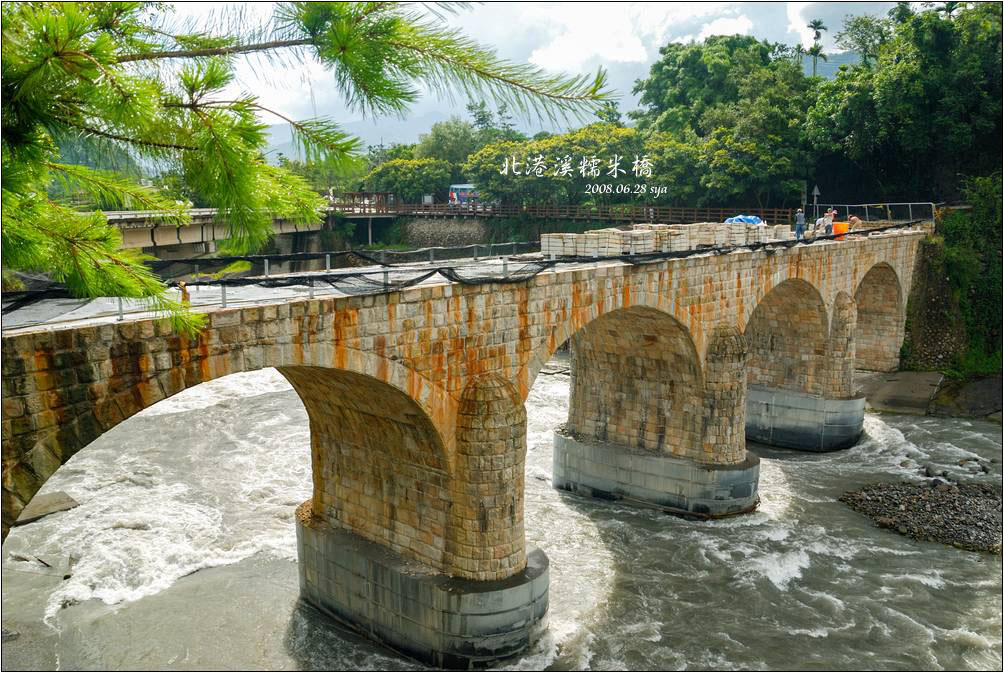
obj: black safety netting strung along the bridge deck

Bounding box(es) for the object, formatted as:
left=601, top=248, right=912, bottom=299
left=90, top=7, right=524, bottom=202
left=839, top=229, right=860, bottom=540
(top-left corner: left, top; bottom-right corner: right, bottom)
left=2, top=220, right=922, bottom=327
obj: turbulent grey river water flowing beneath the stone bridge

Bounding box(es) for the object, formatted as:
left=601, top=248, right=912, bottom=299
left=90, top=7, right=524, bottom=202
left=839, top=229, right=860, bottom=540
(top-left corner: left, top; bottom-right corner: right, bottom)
left=3, top=363, right=1002, bottom=670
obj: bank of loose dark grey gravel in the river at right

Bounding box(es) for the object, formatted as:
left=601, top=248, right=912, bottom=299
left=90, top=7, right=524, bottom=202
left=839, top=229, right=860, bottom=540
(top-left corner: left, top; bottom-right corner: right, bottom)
left=839, top=479, right=1001, bottom=553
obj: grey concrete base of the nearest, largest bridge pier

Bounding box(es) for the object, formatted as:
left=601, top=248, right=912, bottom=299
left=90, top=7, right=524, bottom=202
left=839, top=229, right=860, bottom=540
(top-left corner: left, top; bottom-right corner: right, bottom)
left=296, top=516, right=549, bottom=669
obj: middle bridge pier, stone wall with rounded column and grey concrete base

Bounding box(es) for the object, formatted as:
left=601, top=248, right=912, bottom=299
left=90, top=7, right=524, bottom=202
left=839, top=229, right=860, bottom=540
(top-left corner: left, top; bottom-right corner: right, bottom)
left=553, top=307, right=759, bottom=515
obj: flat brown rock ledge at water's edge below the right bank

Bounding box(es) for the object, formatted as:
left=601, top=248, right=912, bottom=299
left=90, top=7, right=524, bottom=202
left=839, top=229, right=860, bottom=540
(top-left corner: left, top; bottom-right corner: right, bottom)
left=854, top=371, right=1004, bottom=423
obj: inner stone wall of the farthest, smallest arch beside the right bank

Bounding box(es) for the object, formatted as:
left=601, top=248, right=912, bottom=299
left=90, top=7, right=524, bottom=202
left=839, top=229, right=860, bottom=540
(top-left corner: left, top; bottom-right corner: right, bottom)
left=854, top=262, right=907, bottom=372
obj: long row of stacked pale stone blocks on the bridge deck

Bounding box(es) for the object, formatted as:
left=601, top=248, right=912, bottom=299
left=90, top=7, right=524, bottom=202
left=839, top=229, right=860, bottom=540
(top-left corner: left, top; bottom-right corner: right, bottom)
left=540, top=222, right=792, bottom=259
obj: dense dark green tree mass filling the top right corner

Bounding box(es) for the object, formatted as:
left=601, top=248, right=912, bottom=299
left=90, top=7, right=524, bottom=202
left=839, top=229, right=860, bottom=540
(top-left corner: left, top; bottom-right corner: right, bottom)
left=805, top=3, right=1002, bottom=201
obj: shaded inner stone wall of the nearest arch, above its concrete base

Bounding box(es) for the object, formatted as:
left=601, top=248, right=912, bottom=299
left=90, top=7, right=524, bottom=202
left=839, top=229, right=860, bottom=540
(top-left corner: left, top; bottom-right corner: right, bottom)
left=278, top=366, right=451, bottom=572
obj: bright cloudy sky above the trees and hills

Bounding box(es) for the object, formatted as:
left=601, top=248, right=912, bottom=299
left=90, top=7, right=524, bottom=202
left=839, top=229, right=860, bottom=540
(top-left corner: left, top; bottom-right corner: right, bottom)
left=168, top=2, right=895, bottom=142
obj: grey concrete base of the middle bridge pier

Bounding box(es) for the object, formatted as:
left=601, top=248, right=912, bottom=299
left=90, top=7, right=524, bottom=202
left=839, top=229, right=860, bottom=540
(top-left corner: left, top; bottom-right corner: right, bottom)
left=553, top=428, right=760, bottom=516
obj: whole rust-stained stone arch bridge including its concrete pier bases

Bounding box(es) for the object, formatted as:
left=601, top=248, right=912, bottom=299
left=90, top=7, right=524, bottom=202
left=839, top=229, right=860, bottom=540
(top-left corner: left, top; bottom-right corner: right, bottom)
left=2, top=225, right=923, bottom=667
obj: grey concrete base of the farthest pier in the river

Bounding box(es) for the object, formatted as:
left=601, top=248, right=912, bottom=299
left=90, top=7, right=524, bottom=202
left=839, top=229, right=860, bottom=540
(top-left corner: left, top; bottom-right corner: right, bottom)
left=746, top=385, right=864, bottom=451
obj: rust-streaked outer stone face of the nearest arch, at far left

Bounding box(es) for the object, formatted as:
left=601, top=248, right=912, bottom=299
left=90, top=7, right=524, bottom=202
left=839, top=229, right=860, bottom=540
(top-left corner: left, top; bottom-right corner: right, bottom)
left=2, top=308, right=456, bottom=542
